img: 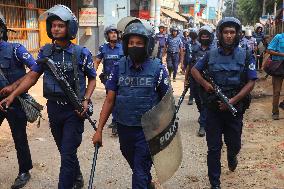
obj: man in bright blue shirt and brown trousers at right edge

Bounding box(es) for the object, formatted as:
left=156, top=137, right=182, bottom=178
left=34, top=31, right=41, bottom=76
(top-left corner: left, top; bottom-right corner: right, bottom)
left=267, top=33, right=284, bottom=120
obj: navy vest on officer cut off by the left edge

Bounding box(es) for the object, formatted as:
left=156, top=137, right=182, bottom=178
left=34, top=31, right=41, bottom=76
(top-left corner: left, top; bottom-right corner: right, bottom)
left=0, top=43, right=26, bottom=88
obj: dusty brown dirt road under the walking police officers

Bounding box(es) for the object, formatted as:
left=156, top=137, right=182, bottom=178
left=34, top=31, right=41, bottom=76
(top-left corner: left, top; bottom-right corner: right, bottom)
left=0, top=70, right=284, bottom=189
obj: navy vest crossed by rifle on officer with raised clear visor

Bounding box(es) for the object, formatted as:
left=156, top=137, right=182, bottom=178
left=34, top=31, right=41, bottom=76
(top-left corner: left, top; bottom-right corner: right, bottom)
left=42, top=44, right=86, bottom=101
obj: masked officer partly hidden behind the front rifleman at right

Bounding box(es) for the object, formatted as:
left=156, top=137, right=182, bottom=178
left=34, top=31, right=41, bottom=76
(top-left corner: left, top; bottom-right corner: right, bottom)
left=185, top=25, right=214, bottom=137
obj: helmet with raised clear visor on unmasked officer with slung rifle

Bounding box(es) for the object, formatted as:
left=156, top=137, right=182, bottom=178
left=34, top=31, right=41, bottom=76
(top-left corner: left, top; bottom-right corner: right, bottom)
left=39, top=4, right=78, bottom=40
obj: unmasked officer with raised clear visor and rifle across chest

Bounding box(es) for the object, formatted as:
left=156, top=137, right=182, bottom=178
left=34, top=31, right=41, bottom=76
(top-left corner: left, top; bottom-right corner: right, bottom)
left=0, top=5, right=96, bottom=189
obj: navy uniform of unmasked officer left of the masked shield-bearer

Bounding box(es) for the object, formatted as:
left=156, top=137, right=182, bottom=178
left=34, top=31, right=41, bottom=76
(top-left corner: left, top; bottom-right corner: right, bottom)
left=32, top=43, right=96, bottom=189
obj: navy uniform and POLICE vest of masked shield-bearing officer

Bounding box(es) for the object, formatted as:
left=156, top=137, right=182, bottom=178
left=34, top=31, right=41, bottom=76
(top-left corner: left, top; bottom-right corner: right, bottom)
left=106, top=58, right=168, bottom=189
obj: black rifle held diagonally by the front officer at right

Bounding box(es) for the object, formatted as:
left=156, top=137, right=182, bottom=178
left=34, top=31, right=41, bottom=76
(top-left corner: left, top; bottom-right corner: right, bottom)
left=202, top=70, right=238, bottom=116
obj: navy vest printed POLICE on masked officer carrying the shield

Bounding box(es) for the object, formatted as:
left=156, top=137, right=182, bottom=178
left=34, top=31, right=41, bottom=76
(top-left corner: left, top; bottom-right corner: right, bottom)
left=115, top=57, right=162, bottom=126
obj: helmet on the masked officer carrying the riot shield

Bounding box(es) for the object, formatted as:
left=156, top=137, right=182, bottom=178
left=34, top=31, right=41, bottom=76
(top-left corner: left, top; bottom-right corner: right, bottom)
left=122, top=22, right=155, bottom=57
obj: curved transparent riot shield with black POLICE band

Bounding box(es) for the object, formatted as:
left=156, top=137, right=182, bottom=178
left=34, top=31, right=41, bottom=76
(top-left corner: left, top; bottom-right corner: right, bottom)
left=141, top=87, right=182, bottom=184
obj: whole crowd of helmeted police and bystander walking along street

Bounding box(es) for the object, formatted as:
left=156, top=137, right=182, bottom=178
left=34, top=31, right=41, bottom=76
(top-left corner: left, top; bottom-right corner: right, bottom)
left=0, top=5, right=284, bottom=189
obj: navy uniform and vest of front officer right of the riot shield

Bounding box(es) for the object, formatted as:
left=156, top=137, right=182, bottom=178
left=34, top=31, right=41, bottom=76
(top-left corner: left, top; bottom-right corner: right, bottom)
left=195, top=47, right=257, bottom=186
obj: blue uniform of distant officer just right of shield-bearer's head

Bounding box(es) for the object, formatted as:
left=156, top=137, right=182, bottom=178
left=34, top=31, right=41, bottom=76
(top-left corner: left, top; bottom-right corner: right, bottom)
left=166, top=35, right=183, bottom=79
